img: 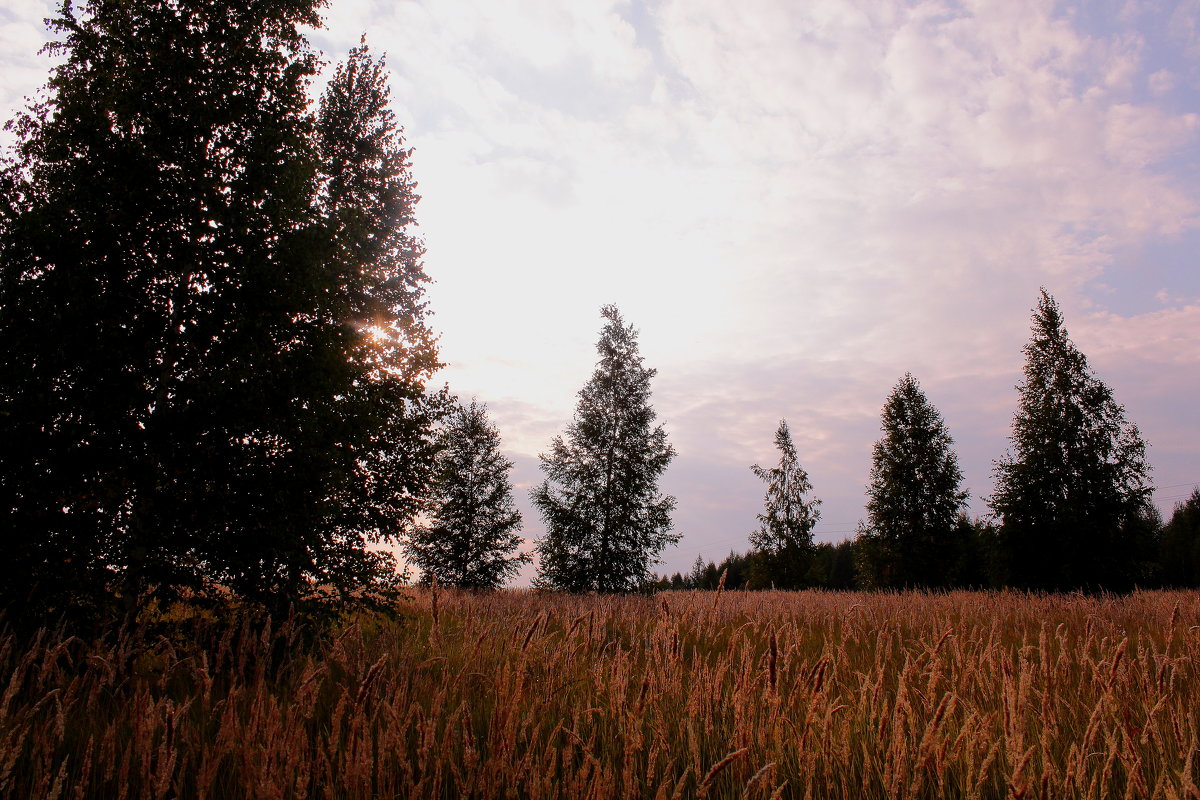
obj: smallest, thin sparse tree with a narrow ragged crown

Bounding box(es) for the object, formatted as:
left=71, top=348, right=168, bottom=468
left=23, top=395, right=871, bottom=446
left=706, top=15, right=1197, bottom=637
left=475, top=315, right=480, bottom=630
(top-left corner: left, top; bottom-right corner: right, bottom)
left=750, top=420, right=821, bottom=589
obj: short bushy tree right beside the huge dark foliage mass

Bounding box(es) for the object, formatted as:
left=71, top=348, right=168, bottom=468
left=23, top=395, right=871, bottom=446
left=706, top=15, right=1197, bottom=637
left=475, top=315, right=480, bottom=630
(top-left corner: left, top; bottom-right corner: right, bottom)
left=404, top=401, right=532, bottom=589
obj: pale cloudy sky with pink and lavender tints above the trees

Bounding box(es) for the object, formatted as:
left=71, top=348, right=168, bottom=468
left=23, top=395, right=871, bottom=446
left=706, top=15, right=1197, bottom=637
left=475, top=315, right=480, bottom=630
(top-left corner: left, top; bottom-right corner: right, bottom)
left=0, top=0, right=1200, bottom=583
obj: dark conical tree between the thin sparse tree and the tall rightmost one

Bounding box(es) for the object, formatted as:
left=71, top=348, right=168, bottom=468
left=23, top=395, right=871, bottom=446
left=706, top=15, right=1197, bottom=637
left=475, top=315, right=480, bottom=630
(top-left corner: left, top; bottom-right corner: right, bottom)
left=858, top=373, right=967, bottom=588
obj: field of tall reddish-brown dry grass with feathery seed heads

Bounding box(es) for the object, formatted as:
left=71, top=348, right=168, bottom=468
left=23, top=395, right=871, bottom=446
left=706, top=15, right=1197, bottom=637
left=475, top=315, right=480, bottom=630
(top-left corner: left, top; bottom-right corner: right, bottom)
left=0, top=591, right=1200, bottom=799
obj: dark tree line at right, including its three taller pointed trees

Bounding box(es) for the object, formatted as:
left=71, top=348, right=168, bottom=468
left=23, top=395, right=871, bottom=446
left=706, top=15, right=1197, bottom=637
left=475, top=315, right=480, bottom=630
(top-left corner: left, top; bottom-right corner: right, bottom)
left=650, top=290, right=1200, bottom=591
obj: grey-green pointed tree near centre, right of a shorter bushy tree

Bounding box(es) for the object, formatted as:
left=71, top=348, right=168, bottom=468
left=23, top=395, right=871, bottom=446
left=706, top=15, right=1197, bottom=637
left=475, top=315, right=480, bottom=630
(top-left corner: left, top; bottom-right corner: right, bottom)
left=532, top=306, right=679, bottom=593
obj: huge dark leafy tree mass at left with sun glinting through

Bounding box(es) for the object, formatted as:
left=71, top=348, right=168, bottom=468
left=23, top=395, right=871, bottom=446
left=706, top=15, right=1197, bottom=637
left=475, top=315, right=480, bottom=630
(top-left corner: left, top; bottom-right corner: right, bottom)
left=0, top=0, right=437, bottom=613
